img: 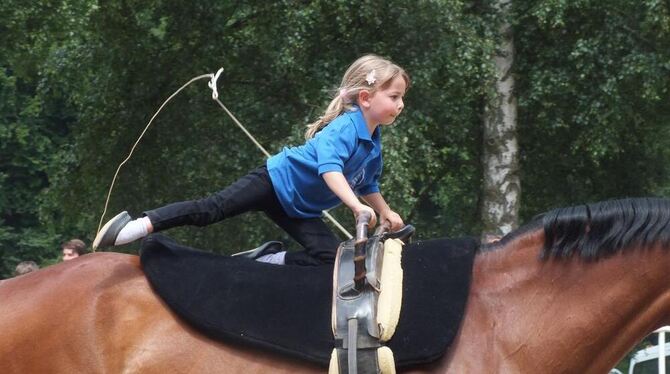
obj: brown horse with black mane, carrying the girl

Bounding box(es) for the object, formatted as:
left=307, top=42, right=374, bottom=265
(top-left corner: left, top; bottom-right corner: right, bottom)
left=0, top=199, right=670, bottom=373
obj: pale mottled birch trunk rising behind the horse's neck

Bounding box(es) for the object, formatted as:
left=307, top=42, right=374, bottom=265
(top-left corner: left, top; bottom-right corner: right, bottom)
left=481, top=0, right=521, bottom=235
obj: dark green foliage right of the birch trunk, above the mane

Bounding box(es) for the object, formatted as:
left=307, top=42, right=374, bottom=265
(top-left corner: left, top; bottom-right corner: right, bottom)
left=515, top=0, right=670, bottom=216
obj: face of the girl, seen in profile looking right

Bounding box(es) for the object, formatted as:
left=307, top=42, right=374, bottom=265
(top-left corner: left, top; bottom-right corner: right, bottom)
left=368, top=76, right=407, bottom=125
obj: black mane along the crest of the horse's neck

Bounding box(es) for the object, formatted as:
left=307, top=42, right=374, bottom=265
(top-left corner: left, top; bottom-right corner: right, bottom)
left=489, top=198, right=670, bottom=260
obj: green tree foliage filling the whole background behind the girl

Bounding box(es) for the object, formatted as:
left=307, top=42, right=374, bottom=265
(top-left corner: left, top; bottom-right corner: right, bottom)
left=0, top=0, right=670, bottom=277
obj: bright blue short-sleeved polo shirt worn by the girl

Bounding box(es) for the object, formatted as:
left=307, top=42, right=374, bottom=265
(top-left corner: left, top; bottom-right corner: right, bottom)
left=267, top=107, right=382, bottom=218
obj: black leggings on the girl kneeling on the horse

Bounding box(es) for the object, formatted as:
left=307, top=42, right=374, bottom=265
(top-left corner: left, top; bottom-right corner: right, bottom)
left=144, top=166, right=340, bottom=265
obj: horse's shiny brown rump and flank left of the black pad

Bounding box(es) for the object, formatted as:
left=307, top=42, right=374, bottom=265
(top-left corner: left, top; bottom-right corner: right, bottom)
left=0, top=253, right=322, bottom=373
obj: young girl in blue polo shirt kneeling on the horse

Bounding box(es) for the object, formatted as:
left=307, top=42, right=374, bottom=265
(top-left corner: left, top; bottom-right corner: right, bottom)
left=93, top=55, right=410, bottom=265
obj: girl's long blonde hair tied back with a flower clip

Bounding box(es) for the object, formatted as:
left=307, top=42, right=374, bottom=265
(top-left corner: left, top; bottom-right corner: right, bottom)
left=305, top=54, right=410, bottom=139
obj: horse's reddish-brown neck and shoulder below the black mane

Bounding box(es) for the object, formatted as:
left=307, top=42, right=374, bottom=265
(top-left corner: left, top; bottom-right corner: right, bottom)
left=443, top=233, right=670, bottom=373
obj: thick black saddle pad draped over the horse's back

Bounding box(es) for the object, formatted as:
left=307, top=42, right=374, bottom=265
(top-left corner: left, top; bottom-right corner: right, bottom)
left=140, top=234, right=477, bottom=367
